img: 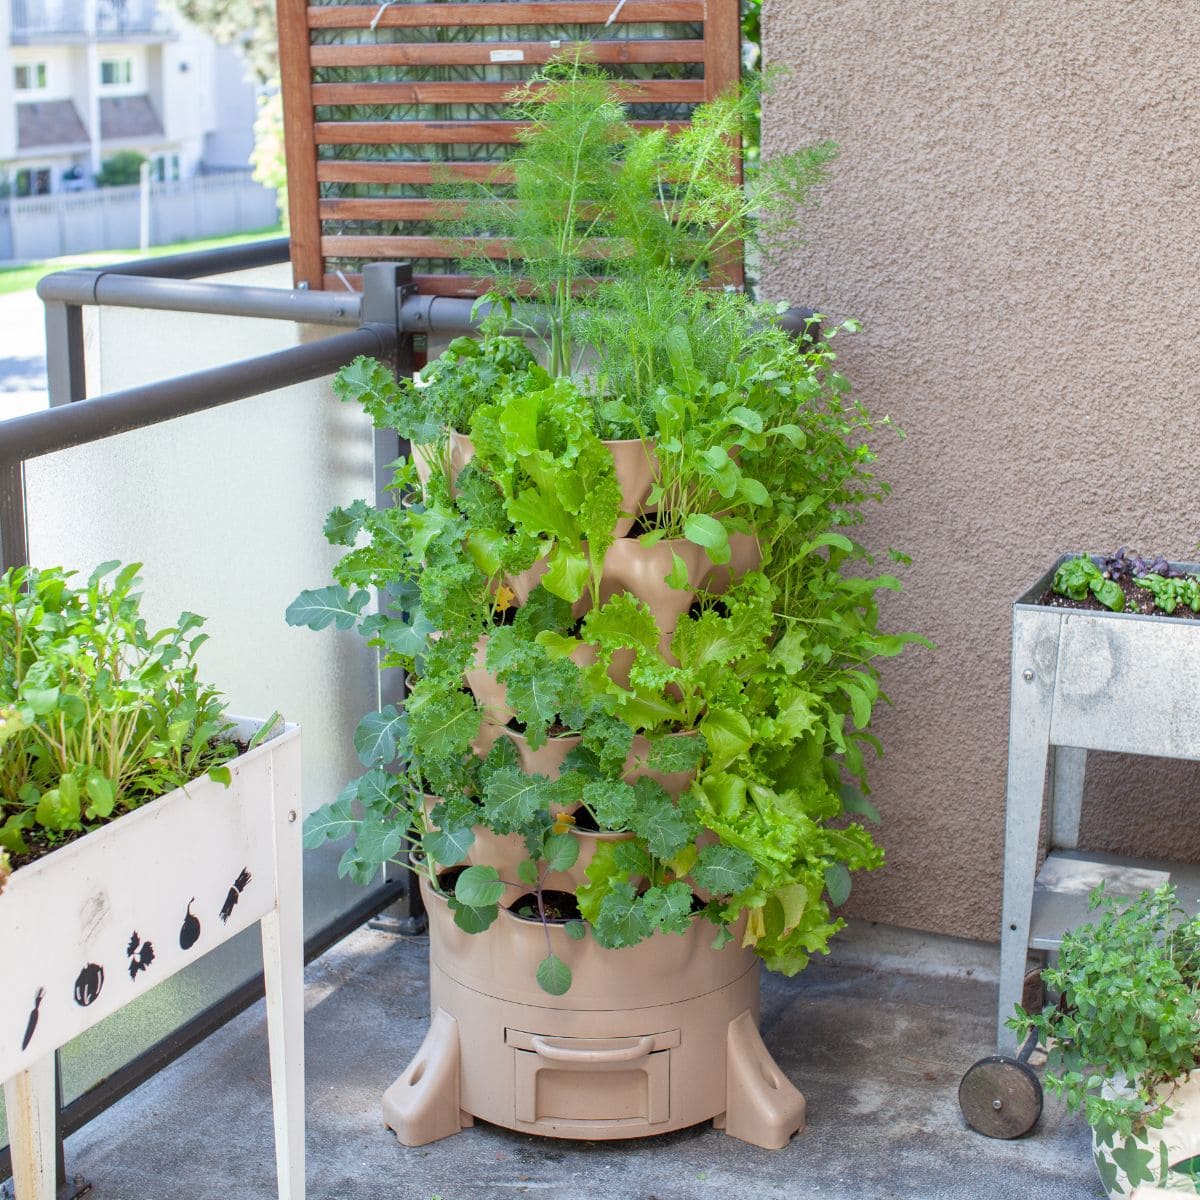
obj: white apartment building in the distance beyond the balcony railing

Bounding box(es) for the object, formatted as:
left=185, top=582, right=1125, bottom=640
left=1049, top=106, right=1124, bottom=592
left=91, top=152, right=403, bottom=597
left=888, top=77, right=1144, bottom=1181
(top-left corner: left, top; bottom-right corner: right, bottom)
left=0, top=0, right=256, bottom=196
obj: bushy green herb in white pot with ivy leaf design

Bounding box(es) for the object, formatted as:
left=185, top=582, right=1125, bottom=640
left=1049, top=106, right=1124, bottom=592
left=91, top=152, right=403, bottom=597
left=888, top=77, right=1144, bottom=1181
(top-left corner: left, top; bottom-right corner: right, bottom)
left=1010, top=884, right=1200, bottom=1198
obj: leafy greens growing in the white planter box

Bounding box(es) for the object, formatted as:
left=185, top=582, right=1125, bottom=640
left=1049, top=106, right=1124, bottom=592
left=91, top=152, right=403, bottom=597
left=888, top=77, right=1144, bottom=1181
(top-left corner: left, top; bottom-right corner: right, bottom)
left=0, top=563, right=236, bottom=856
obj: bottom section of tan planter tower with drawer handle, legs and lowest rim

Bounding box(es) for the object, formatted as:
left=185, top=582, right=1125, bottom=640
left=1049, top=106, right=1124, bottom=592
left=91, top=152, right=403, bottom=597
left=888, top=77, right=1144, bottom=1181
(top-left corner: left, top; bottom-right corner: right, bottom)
left=383, top=882, right=804, bottom=1150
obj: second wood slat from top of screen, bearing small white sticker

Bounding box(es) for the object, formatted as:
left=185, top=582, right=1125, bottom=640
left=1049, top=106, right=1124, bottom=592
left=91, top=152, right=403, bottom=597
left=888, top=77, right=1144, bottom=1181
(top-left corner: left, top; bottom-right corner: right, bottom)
left=308, top=38, right=704, bottom=67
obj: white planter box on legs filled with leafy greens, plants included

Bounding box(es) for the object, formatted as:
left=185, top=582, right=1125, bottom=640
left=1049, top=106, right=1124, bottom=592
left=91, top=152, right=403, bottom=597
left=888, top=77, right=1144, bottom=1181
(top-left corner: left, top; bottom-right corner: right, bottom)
left=0, top=563, right=304, bottom=1196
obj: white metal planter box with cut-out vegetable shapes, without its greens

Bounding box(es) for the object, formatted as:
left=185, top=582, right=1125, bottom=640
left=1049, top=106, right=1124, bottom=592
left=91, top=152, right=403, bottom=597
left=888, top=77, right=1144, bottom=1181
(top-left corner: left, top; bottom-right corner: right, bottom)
left=0, top=721, right=304, bottom=1200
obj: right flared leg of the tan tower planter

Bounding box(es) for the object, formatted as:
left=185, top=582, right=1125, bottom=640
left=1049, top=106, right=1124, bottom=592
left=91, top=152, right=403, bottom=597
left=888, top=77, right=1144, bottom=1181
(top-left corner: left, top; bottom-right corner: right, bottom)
left=713, top=1012, right=805, bottom=1150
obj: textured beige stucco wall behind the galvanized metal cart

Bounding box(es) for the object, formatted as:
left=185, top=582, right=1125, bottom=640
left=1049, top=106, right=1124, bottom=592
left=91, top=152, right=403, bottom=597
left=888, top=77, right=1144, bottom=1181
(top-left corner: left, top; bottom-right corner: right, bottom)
left=763, top=0, right=1200, bottom=940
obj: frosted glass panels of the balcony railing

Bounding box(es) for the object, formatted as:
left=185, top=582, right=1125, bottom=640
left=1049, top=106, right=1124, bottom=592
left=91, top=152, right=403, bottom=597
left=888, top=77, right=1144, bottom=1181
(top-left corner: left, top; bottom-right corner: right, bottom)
left=0, top=268, right=398, bottom=1145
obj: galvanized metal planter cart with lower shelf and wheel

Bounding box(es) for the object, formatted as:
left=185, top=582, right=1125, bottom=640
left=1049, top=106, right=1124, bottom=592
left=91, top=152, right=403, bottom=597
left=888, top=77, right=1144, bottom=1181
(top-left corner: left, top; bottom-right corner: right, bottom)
left=959, top=557, right=1200, bottom=1138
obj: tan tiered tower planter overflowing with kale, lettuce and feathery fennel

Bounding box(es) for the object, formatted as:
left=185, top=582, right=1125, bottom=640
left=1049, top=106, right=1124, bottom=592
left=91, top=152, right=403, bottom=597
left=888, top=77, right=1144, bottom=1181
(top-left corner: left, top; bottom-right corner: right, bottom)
left=288, top=62, right=911, bottom=1146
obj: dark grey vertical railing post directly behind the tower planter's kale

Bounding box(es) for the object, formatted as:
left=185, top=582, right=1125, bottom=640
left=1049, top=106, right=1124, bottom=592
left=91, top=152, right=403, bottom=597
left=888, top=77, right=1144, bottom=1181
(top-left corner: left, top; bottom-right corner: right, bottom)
left=361, top=263, right=426, bottom=935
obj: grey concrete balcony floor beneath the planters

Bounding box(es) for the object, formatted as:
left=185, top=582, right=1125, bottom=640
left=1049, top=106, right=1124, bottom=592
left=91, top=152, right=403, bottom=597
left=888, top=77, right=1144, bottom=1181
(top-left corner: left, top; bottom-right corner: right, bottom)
left=67, top=926, right=1102, bottom=1200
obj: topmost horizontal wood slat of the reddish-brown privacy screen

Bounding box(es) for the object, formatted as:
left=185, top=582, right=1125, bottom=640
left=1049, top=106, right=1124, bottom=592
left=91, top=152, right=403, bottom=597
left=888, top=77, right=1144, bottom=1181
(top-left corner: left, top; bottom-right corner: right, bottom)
left=308, top=0, right=704, bottom=29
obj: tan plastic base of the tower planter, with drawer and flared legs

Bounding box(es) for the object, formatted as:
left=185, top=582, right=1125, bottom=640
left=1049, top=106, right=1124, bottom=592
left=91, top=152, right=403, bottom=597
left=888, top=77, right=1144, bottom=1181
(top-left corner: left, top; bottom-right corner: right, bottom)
left=383, top=904, right=805, bottom=1150
